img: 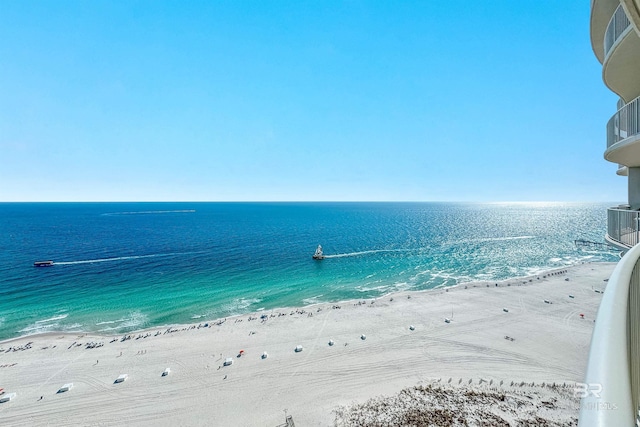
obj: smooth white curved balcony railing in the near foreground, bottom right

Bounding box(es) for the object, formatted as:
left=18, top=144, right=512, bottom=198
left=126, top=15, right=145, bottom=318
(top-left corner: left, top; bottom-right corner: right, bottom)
left=575, top=241, right=640, bottom=427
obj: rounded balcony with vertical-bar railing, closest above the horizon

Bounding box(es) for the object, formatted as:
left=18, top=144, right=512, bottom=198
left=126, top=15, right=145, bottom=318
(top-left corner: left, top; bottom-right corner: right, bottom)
left=604, top=97, right=640, bottom=167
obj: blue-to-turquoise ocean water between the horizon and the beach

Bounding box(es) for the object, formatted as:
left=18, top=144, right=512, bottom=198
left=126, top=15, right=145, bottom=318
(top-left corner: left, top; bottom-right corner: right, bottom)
left=0, top=203, right=618, bottom=339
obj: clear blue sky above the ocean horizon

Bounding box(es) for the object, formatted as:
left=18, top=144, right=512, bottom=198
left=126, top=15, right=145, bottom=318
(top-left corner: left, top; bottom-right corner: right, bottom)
left=0, top=0, right=627, bottom=202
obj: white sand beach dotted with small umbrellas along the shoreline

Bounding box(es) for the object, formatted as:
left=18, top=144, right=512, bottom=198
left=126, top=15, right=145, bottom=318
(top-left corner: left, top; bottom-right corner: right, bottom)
left=0, top=263, right=615, bottom=426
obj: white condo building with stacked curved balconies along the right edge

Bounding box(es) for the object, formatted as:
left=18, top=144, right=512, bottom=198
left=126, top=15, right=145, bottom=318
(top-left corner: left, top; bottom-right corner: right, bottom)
left=576, top=0, right=640, bottom=427
